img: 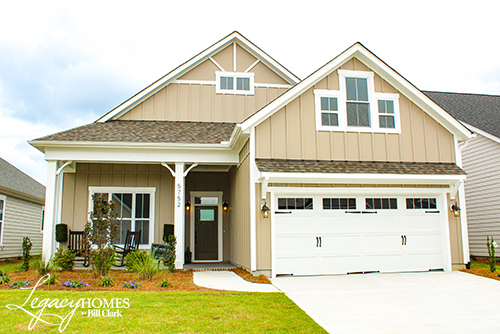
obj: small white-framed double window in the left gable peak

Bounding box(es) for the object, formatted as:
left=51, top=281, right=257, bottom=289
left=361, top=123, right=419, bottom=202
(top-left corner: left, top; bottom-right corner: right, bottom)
left=215, top=72, right=255, bottom=95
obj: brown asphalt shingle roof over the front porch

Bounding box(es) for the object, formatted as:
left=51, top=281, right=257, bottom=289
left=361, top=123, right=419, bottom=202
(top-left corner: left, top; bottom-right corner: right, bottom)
left=35, top=121, right=236, bottom=144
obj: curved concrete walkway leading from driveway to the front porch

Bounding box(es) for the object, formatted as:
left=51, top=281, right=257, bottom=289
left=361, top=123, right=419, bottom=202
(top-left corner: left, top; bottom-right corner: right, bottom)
left=193, top=271, right=280, bottom=292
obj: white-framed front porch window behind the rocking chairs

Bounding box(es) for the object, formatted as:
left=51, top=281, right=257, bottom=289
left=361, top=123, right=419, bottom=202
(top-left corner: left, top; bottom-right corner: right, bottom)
left=90, top=187, right=155, bottom=245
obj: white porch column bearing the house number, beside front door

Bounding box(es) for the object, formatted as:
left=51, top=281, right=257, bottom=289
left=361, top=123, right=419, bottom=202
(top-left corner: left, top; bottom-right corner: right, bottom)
left=174, top=162, right=186, bottom=269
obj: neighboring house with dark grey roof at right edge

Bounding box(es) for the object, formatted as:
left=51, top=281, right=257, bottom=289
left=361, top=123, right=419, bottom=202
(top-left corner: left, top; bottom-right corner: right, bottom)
left=424, top=92, right=500, bottom=256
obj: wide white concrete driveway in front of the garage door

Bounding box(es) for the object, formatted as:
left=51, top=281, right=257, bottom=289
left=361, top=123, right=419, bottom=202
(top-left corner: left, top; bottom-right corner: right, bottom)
left=272, top=272, right=500, bottom=334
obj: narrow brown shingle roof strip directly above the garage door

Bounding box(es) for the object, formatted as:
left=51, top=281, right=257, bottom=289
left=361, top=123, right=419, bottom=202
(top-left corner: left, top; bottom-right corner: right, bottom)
left=255, top=159, right=465, bottom=175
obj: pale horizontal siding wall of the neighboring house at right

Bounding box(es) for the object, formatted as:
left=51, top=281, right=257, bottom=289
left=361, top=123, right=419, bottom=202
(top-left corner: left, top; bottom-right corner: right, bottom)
left=462, top=134, right=500, bottom=256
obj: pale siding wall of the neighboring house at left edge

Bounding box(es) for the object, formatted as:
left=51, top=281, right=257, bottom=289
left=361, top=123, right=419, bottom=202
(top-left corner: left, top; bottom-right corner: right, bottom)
left=0, top=196, right=43, bottom=258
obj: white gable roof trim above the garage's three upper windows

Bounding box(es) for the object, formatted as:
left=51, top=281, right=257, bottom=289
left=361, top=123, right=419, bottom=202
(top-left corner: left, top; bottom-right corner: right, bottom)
left=241, top=42, right=472, bottom=140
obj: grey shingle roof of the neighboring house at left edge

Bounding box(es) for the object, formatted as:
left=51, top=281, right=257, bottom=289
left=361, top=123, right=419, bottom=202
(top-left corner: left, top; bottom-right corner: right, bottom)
left=0, top=158, right=45, bottom=197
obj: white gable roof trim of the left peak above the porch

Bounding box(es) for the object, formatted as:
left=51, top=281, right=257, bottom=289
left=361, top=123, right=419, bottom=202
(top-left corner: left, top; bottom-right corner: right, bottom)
left=96, top=31, right=300, bottom=122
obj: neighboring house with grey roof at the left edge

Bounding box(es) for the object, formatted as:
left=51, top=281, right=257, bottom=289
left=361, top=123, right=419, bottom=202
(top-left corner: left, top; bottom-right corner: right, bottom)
left=0, top=158, right=45, bottom=258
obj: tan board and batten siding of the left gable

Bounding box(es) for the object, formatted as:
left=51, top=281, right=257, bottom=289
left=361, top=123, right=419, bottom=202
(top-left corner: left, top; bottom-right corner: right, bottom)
left=120, top=45, right=289, bottom=123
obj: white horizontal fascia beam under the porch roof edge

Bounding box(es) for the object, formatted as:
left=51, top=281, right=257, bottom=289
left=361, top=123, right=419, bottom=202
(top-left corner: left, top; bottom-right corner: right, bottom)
left=45, top=147, right=239, bottom=165
